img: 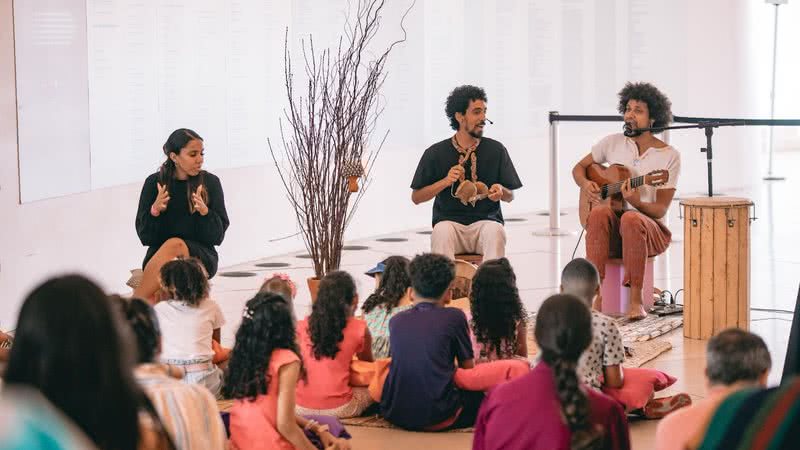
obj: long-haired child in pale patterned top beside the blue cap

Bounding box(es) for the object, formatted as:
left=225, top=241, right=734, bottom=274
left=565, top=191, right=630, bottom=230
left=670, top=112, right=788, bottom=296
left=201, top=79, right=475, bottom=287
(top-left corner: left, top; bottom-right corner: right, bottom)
left=361, top=256, right=414, bottom=359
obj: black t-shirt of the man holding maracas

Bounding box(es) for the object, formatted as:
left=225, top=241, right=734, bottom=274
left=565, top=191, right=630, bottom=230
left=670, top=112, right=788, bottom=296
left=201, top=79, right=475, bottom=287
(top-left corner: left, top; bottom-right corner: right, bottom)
left=411, top=138, right=522, bottom=225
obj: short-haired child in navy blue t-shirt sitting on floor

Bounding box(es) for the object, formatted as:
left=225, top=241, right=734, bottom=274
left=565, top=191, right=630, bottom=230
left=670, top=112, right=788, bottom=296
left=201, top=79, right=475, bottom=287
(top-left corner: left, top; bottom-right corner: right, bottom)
left=381, top=254, right=483, bottom=430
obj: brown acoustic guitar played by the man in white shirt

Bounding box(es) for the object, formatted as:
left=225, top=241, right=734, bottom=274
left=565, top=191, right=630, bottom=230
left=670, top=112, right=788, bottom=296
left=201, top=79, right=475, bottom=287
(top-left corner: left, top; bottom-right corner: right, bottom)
left=578, top=164, right=669, bottom=228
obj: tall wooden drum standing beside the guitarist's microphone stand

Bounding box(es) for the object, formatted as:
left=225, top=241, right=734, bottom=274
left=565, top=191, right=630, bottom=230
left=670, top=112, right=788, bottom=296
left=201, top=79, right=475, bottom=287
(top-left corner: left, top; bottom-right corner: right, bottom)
left=680, top=197, right=753, bottom=339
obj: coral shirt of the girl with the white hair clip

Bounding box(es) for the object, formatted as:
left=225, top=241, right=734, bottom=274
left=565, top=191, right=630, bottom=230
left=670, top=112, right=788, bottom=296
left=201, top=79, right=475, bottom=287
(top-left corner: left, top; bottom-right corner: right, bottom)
left=230, top=348, right=300, bottom=450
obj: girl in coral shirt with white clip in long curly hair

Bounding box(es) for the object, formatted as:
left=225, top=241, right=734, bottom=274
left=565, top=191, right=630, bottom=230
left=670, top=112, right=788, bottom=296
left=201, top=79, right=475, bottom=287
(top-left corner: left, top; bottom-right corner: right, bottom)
left=223, top=292, right=349, bottom=450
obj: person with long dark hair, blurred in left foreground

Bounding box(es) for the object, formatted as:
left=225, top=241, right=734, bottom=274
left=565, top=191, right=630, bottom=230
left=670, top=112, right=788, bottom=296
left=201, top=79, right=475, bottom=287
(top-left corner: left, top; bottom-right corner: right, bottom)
left=4, top=275, right=175, bottom=450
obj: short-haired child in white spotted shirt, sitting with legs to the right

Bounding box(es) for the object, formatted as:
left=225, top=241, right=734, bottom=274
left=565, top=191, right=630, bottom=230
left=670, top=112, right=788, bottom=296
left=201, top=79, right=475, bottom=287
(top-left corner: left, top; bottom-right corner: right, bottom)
left=561, top=258, right=691, bottom=419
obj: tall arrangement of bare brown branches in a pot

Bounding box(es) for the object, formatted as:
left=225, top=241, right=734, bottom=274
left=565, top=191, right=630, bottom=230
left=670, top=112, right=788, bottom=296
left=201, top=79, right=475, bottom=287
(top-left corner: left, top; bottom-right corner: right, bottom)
left=267, top=0, right=413, bottom=300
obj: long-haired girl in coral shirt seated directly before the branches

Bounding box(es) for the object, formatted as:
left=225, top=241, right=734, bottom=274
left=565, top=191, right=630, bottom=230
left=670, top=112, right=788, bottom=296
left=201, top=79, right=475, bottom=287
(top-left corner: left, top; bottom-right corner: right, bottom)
left=296, top=271, right=373, bottom=418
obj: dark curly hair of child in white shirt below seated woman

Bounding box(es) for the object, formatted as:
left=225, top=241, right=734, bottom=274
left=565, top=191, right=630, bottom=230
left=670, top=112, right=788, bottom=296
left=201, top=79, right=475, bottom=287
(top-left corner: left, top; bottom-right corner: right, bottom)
left=161, top=256, right=208, bottom=306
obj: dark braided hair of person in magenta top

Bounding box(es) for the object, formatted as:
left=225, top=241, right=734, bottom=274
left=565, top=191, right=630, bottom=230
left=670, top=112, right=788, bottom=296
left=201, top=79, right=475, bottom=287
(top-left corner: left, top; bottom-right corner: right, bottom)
left=535, top=294, right=602, bottom=450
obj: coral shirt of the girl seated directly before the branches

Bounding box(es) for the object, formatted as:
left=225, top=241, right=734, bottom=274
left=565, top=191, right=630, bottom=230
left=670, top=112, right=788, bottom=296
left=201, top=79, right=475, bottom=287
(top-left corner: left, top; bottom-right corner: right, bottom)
left=296, top=317, right=367, bottom=409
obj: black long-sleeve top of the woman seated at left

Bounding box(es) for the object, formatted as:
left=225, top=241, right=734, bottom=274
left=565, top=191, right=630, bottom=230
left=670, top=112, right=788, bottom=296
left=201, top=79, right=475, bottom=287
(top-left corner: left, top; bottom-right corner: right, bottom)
left=136, top=172, right=230, bottom=277
